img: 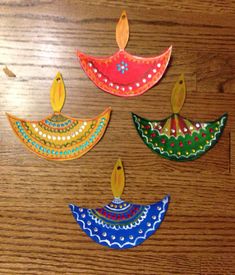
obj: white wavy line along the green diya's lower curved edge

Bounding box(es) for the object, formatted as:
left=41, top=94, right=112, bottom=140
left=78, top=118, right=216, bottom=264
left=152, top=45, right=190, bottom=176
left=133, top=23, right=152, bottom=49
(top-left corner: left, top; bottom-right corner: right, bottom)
left=134, top=115, right=226, bottom=159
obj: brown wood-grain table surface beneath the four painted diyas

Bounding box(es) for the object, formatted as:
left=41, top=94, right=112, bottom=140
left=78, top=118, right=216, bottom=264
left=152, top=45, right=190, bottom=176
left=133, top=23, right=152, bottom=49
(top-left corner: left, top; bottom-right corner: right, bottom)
left=0, top=0, right=235, bottom=275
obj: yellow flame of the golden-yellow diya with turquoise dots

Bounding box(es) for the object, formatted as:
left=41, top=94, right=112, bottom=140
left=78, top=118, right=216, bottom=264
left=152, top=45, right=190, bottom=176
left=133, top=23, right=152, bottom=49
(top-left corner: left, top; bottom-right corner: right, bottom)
left=50, top=73, right=65, bottom=113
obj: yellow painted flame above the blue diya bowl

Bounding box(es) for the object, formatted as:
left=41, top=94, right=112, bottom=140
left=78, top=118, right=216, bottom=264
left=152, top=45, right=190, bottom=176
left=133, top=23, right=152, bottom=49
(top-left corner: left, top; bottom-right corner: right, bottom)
left=111, top=159, right=125, bottom=198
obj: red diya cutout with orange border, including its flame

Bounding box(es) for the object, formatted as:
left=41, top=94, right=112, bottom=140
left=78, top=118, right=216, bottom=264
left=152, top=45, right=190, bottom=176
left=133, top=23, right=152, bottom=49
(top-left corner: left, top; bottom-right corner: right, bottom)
left=77, top=11, right=172, bottom=97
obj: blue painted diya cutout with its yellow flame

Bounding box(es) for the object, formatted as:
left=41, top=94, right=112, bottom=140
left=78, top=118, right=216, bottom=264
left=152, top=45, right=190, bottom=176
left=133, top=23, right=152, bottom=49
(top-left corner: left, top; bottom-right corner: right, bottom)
left=70, top=160, right=170, bottom=249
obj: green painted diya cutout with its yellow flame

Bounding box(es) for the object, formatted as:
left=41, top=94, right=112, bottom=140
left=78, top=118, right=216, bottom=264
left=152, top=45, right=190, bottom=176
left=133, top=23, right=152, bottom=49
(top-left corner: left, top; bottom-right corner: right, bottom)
left=132, top=75, right=227, bottom=161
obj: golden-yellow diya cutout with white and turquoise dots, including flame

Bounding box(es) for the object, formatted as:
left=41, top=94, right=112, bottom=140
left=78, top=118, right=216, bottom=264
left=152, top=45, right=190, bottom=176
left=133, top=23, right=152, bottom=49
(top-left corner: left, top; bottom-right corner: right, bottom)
left=7, top=73, right=111, bottom=161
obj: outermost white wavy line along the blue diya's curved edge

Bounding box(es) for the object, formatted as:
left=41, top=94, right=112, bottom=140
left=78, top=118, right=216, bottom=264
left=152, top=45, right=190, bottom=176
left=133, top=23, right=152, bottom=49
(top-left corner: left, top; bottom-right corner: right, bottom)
left=70, top=197, right=168, bottom=248
